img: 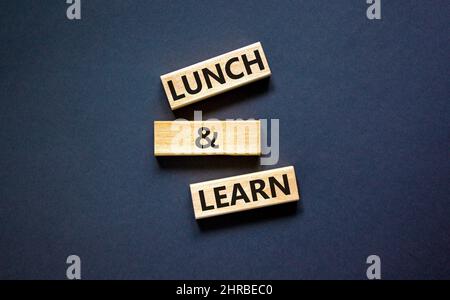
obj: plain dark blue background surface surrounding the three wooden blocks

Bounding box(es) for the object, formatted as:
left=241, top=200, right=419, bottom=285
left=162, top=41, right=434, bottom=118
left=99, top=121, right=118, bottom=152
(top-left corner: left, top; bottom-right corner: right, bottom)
left=0, top=0, right=450, bottom=279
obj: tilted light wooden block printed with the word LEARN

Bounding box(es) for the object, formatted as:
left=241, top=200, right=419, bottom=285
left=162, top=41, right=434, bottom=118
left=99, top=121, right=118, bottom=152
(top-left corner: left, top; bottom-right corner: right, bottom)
left=190, top=167, right=300, bottom=219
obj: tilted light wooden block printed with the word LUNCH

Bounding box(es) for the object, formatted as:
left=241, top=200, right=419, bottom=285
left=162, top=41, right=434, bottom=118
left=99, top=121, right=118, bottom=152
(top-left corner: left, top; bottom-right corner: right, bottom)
left=161, top=42, right=271, bottom=110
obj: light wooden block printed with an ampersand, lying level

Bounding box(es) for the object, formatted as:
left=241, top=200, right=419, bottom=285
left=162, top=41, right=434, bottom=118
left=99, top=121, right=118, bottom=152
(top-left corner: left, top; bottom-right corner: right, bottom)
left=154, top=120, right=261, bottom=156
